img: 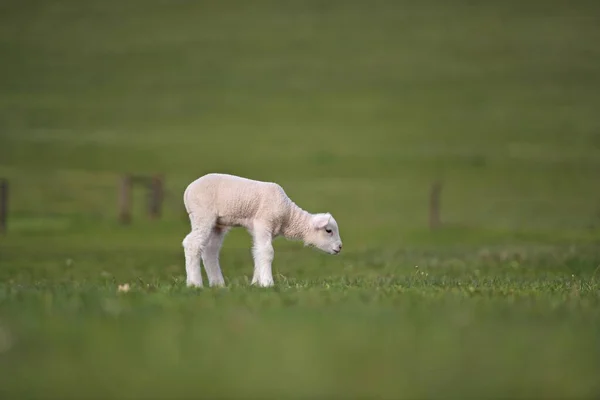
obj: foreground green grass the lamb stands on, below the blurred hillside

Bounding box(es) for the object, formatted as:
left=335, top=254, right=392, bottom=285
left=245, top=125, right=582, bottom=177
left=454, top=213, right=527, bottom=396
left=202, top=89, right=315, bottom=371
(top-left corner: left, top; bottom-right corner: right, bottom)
left=0, top=246, right=600, bottom=398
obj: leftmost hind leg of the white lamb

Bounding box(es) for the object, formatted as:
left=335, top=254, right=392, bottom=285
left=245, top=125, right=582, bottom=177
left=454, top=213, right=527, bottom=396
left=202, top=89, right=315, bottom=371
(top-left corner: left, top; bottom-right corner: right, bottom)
left=182, top=216, right=213, bottom=287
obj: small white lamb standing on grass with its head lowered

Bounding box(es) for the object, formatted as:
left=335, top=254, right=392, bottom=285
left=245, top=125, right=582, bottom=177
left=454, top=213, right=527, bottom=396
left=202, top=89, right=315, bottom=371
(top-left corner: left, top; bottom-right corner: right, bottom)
left=182, top=173, right=342, bottom=287
